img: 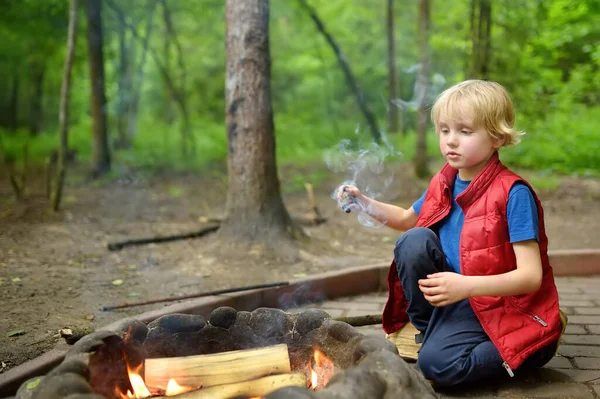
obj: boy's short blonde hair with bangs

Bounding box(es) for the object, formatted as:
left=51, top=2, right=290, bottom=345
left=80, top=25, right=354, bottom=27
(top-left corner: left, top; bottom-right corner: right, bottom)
left=431, top=80, right=525, bottom=147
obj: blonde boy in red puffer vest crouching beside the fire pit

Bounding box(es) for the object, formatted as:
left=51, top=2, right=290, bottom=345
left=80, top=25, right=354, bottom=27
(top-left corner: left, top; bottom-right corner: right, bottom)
left=338, top=80, right=566, bottom=386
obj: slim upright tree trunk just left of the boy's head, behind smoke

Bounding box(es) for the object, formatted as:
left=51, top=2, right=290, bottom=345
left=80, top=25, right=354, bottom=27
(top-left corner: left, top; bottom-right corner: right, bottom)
left=415, top=0, right=429, bottom=178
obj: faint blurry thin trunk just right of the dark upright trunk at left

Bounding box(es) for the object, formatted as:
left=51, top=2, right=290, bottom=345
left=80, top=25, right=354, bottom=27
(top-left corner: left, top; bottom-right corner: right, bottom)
left=115, top=14, right=131, bottom=149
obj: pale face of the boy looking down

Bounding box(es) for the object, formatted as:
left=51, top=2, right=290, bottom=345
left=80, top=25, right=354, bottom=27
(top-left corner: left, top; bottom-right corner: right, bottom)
left=438, top=114, right=502, bottom=180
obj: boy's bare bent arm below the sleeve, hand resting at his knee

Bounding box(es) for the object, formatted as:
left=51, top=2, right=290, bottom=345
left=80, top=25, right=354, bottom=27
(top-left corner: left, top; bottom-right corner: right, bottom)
left=419, top=240, right=542, bottom=306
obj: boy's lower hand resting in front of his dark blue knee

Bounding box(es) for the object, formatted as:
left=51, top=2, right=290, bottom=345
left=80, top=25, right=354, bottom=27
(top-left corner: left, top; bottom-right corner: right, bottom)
left=419, top=272, right=471, bottom=306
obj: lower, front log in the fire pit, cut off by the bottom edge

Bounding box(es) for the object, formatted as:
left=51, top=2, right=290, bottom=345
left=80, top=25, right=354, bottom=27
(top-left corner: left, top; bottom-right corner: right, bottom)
left=172, top=373, right=306, bottom=399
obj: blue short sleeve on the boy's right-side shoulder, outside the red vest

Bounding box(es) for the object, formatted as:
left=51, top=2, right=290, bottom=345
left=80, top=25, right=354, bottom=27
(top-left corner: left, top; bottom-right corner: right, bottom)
left=506, top=182, right=539, bottom=243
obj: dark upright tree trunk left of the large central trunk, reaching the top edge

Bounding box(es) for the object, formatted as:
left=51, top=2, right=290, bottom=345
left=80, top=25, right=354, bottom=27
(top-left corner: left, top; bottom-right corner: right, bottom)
left=87, top=0, right=110, bottom=177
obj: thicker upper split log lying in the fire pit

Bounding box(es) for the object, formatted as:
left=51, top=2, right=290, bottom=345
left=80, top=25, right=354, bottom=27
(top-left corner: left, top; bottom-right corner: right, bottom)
left=144, top=344, right=291, bottom=389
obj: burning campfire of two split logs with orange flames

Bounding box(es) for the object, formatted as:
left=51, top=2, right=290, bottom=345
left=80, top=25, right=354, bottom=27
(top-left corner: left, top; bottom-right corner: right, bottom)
left=115, top=344, right=335, bottom=399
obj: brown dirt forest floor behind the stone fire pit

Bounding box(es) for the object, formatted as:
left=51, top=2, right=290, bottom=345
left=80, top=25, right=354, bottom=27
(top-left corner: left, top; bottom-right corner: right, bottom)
left=0, top=160, right=600, bottom=373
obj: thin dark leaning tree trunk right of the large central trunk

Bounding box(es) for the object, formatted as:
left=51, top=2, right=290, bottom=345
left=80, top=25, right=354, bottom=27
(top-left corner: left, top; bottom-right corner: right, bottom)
left=300, top=0, right=381, bottom=143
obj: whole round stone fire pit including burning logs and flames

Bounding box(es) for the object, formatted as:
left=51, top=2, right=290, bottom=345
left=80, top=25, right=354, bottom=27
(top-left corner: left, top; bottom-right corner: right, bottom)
left=17, top=307, right=437, bottom=399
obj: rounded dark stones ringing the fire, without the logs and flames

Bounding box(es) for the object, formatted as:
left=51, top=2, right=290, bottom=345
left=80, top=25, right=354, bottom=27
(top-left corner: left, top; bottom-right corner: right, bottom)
left=10, top=307, right=437, bottom=399
